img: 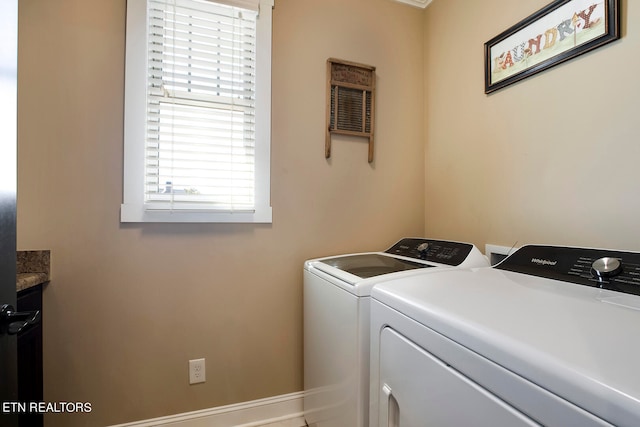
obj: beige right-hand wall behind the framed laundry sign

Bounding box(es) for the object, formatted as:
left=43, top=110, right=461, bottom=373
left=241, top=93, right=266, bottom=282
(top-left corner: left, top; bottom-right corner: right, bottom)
left=425, top=0, right=640, bottom=250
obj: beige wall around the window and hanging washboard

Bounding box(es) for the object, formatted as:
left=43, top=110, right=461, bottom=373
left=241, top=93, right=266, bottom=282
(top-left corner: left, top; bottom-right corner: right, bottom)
left=18, top=0, right=424, bottom=427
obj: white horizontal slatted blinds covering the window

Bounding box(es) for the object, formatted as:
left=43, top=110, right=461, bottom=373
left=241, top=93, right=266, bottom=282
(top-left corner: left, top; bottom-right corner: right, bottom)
left=144, top=0, right=257, bottom=212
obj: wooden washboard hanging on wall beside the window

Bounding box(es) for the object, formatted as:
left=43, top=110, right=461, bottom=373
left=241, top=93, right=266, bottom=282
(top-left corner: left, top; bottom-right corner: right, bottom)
left=324, top=58, right=376, bottom=163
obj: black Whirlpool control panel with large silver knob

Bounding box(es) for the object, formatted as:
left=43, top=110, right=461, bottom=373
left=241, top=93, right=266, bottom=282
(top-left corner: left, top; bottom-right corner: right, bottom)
left=494, top=245, right=640, bottom=295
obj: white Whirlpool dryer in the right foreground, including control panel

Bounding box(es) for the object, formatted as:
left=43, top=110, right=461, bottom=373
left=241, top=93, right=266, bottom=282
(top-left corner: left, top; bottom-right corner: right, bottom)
left=370, top=246, right=640, bottom=427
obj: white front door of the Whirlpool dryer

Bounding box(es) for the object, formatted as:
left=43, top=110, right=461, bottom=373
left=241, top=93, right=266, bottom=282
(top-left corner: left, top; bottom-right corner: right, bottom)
left=378, top=327, right=540, bottom=427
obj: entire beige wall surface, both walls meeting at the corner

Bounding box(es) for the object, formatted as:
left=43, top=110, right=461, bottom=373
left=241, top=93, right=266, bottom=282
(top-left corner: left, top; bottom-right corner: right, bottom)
left=18, top=0, right=640, bottom=426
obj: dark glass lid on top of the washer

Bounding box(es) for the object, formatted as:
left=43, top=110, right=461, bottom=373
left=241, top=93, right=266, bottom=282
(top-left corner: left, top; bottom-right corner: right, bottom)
left=320, top=253, right=433, bottom=279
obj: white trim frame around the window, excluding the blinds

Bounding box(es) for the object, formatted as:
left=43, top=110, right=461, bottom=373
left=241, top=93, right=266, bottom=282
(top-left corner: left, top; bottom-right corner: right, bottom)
left=120, top=0, right=274, bottom=223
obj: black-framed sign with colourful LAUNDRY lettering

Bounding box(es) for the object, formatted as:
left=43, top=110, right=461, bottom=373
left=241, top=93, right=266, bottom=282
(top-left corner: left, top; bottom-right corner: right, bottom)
left=484, top=0, right=620, bottom=93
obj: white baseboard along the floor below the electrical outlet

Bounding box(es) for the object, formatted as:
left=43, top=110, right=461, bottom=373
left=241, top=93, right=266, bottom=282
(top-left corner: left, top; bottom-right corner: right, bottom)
left=110, top=392, right=304, bottom=427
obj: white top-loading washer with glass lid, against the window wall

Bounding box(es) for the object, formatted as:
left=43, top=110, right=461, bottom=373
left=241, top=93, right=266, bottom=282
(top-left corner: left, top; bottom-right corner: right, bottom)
left=304, top=238, right=489, bottom=427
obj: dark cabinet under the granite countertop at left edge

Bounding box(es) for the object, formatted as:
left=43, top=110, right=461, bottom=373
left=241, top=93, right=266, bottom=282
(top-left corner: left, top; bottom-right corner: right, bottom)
left=16, top=285, right=44, bottom=427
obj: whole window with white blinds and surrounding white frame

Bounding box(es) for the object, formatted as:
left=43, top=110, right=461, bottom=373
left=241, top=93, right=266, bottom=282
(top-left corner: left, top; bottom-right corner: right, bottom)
left=121, top=0, right=273, bottom=222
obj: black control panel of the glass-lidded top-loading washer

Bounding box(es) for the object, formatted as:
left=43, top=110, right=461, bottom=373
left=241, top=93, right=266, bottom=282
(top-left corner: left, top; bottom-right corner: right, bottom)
left=385, top=238, right=473, bottom=266
